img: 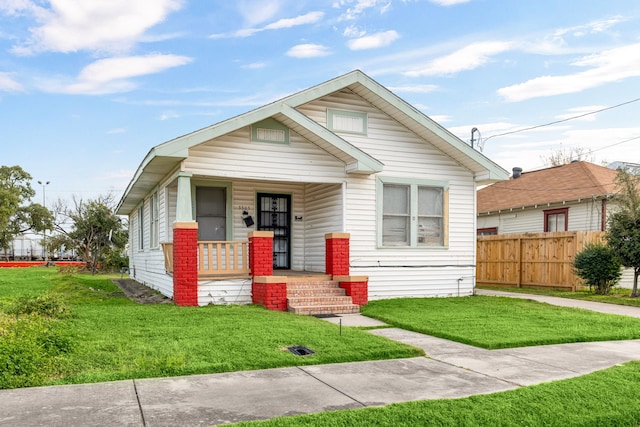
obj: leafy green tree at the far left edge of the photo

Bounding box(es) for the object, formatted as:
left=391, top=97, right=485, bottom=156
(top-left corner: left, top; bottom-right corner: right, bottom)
left=0, top=166, right=53, bottom=258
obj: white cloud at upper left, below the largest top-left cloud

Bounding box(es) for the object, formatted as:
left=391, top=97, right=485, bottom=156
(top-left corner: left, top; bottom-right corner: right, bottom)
left=43, top=54, right=191, bottom=95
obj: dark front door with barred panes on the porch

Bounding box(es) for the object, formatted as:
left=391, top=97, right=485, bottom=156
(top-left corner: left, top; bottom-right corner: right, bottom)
left=258, top=193, right=291, bottom=270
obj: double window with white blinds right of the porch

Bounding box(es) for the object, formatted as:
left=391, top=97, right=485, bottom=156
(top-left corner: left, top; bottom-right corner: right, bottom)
left=378, top=179, right=448, bottom=247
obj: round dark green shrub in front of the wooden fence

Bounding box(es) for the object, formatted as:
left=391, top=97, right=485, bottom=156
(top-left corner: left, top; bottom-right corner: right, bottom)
left=573, top=243, right=622, bottom=295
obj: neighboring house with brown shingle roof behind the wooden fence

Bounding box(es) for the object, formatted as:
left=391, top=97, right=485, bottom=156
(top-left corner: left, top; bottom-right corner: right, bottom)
left=477, top=161, right=617, bottom=235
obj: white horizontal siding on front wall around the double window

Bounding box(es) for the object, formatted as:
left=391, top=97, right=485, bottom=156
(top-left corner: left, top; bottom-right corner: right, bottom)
left=299, top=91, right=475, bottom=299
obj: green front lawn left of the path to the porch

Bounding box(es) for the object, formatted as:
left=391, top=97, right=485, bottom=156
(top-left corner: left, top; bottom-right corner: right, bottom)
left=0, top=268, right=424, bottom=385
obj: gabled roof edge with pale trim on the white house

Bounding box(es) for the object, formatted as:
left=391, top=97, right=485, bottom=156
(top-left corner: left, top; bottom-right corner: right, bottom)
left=116, top=70, right=509, bottom=215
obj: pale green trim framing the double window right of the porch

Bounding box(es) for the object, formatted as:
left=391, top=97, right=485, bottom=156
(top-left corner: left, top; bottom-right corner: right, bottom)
left=376, top=177, right=449, bottom=250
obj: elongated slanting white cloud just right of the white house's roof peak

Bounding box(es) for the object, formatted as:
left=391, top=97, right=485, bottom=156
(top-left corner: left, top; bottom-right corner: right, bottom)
left=404, top=42, right=512, bottom=77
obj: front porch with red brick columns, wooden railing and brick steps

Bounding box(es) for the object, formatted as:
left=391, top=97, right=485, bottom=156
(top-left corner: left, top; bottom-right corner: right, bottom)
left=162, top=231, right=368, bottom=315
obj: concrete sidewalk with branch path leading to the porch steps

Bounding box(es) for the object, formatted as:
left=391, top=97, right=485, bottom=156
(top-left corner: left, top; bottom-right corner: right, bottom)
left=0, top=300, right=640, bottom=427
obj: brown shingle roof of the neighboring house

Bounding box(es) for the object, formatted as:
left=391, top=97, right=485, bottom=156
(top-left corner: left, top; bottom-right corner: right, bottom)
left=477, top=162, right=617, bottom=213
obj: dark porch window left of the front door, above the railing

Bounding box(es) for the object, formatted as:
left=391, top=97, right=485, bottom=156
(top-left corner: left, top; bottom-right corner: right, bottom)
left=196, top=187, right=227, bottom=241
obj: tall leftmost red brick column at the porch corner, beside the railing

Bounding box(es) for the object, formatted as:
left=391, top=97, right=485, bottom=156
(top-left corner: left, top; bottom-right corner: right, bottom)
left=173, top=222, right=198, bottom=306
